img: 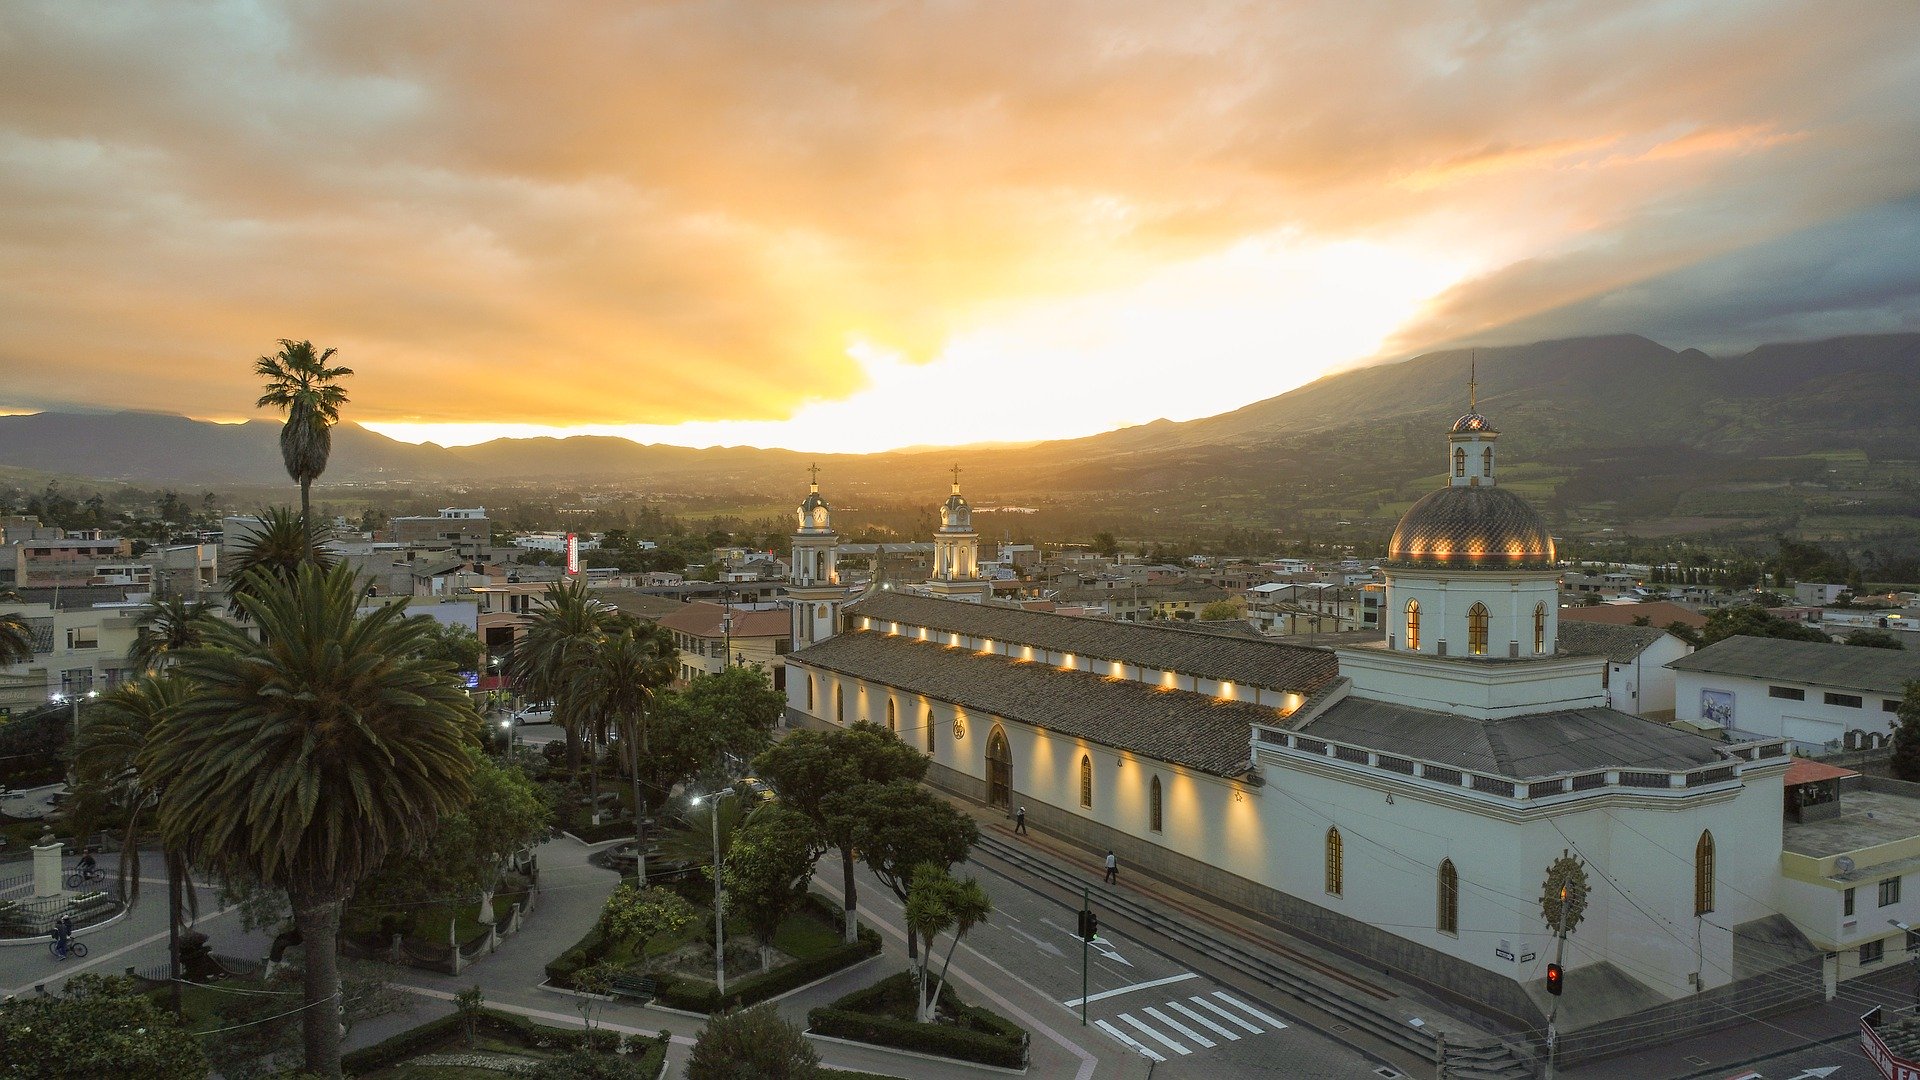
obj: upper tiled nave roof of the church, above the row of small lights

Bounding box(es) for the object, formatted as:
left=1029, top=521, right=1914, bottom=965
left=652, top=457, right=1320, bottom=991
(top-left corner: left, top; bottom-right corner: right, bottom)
left=847, top=592, right=1340, bottom=694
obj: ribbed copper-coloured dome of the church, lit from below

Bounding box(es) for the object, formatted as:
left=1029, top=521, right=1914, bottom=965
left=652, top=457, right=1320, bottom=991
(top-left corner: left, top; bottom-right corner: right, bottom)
left=1386, top=486, right=1553, bottom=571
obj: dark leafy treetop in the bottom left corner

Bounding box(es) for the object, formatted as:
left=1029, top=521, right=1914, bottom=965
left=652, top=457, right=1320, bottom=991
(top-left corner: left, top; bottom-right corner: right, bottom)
left=0, top=974, right=207, bottom=1080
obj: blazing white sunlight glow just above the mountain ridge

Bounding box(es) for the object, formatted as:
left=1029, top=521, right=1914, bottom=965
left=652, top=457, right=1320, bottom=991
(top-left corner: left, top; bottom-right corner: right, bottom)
left=361, top=231, right=1484, bottom=454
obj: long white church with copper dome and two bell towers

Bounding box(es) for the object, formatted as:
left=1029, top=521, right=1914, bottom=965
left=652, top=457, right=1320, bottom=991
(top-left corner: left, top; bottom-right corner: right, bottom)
left=787, top=397, right=1820, bottom=1038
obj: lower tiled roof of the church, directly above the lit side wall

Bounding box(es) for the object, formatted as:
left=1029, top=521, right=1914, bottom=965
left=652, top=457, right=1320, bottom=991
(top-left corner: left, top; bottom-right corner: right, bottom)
left=787, top=630, right=1279, bottom=776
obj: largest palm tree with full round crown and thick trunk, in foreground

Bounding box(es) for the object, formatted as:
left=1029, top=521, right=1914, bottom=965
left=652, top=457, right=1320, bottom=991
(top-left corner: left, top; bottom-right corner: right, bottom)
left=136, top=563, right=480, bottom=1076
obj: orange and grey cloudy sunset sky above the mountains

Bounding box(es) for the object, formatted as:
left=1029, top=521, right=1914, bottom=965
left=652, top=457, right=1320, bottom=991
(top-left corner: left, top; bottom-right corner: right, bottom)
left=0, top=0, right=1920, bottom=452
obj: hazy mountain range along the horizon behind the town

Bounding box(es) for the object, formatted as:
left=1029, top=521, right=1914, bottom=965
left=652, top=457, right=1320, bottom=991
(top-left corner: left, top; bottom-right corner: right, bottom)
left=11, top=334, right=1920, bottom=519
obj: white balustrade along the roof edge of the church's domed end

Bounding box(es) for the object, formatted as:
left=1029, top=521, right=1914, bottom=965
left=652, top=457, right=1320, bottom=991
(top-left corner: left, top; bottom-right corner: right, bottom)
left=1254, top=726, right=1788, bottom=803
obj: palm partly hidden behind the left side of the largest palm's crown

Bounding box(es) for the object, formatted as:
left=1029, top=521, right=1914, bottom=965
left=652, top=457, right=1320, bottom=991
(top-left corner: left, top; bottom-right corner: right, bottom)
left=73, top=676, right=200, bottom=1001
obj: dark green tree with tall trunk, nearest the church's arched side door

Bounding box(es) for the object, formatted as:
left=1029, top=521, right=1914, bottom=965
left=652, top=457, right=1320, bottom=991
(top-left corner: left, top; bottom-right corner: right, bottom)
left=753, top=723, right=927, bottom=942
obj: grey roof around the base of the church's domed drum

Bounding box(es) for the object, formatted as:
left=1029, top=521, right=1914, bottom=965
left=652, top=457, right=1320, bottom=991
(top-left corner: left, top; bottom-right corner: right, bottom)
left=1300, top=698, right=1730, bottom=780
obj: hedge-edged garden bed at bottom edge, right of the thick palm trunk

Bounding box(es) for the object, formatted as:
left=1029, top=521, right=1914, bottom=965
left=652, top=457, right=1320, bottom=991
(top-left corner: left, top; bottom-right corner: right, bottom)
left=340, top=1009, right=666, bottom=1078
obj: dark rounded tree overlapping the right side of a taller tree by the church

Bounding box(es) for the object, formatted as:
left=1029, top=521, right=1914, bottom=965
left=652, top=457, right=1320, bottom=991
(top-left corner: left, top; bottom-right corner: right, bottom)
left=826, top=780, right=979, bottom=959
